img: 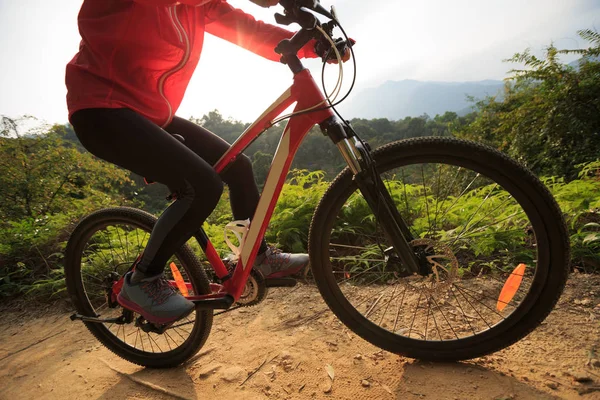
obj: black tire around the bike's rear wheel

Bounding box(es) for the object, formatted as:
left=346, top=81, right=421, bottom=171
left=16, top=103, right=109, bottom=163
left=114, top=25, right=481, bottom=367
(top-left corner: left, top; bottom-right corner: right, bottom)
left=65, top=207, right=213, bottom=368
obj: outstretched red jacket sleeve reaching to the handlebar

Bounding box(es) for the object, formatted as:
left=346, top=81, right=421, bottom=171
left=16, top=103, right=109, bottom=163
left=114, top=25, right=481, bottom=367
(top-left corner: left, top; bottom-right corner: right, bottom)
left=205, top=0, right=317, bottom=61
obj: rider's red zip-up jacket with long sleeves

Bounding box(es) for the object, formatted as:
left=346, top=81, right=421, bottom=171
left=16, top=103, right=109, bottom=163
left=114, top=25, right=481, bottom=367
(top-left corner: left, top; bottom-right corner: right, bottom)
left=66, top=0, right=316, bottom=126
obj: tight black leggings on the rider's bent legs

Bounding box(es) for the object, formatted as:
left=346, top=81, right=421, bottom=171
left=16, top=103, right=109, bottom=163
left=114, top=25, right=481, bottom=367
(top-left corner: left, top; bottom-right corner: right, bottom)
left=71, top=108, right=266, bottom=275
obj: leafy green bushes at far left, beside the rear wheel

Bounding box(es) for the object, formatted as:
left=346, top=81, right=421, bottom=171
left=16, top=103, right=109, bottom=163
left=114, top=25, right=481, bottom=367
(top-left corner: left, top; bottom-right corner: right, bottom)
left=0, top=118, right=130, bottom=296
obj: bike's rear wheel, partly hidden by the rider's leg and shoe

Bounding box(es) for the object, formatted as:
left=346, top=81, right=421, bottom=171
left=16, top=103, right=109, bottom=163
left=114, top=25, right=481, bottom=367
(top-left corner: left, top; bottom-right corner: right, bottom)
left=65, top=207, right=213, bottom=367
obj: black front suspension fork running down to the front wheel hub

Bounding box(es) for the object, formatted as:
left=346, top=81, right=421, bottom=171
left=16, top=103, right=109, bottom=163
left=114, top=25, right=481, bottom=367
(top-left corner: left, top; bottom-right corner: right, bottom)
left=336, top=131, right=427, bottom=275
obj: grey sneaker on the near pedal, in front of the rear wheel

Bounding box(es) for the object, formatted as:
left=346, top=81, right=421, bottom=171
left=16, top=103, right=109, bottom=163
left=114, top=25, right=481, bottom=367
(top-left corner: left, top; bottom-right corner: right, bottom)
left=117, top=272, right=195, bottom=325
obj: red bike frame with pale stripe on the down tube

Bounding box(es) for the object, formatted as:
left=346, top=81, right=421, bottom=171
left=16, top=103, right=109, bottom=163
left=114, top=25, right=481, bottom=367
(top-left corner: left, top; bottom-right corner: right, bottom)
left=188, top=69, right=334, bottom=301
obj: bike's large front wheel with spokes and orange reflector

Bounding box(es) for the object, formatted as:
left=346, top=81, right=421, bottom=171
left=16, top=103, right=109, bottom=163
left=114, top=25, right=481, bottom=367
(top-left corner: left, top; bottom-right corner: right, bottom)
left=309, top=138, right=569, bottom=361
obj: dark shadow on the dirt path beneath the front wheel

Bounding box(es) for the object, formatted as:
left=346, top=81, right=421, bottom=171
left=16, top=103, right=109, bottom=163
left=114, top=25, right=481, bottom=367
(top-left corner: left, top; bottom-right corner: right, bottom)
left=395, top=361, right=559, bottom=400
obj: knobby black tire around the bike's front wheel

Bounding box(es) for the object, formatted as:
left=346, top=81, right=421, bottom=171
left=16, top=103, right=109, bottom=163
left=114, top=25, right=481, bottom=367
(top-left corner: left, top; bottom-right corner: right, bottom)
left=309, top=137, right=570, bottom=361
